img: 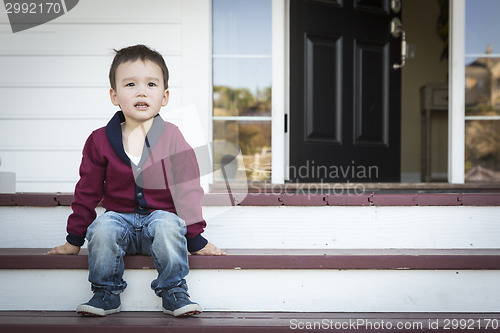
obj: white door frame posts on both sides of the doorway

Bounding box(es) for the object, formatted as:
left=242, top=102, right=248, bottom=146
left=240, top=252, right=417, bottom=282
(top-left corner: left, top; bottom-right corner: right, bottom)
left=271, top=0, right=465, bottom=184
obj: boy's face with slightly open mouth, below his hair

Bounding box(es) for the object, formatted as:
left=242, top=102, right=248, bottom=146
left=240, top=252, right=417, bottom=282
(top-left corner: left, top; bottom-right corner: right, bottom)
left=109, top=60, right=169, bottom=123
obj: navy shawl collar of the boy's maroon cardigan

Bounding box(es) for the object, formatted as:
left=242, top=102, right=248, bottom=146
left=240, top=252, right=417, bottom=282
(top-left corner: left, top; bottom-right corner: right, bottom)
left=106, top=111, right=165, bottom=166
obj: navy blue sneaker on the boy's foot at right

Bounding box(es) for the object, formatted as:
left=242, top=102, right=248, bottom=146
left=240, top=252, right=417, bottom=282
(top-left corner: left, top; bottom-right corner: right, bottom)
left=161, top=284, right=202, bottom=317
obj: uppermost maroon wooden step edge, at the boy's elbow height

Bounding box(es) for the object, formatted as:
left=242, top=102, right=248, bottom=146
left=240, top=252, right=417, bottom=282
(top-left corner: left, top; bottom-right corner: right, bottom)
left=0, top=190, right=500, bottom=207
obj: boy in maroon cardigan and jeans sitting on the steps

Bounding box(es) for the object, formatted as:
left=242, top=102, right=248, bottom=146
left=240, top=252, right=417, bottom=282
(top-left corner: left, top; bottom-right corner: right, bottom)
left=49, top=45, right=225, bottom=317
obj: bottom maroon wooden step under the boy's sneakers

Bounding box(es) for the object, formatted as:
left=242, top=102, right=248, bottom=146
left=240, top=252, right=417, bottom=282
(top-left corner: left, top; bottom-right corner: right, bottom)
left=0, top=311, right=500, bottom=333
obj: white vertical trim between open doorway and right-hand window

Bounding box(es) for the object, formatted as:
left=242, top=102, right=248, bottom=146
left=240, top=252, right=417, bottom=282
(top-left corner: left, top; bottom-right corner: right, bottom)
left=448, top=0, right=465, bottom=184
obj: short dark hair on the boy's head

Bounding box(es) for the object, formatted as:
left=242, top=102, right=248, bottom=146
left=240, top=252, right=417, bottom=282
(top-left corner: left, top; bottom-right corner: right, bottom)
left=109, top=44, right=168, bottom=90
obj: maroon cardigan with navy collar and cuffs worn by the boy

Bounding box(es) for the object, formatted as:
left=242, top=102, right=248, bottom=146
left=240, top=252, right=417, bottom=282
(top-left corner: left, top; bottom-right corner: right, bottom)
left=66, top=111, right=207, bottom=252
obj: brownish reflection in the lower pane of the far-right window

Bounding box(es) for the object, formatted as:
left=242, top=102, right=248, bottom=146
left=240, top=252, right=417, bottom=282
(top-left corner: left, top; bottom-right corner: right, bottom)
left=465, top=120, right=500, bottom=181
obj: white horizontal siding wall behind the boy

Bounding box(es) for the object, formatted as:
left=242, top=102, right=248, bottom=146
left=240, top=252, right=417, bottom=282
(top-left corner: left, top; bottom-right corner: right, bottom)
left=0, top=0, right=210, bottom=192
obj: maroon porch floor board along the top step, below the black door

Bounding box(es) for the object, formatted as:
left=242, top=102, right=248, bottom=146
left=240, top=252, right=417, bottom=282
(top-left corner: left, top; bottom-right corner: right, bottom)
left=0, top=191, right=500, bottom=207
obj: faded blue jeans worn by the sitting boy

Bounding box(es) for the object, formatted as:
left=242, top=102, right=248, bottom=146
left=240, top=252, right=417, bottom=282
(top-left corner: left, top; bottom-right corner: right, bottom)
left=87, top=211, right=189, bottom=296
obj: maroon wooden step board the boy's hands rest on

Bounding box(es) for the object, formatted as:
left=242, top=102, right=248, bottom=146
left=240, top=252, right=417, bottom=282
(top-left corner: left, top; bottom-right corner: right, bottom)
left=0, top=248, right=500, bottom=270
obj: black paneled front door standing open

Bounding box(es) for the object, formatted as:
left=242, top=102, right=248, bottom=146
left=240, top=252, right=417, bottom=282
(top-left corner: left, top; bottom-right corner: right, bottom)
left=290, top=0, right=401, bottom=182
